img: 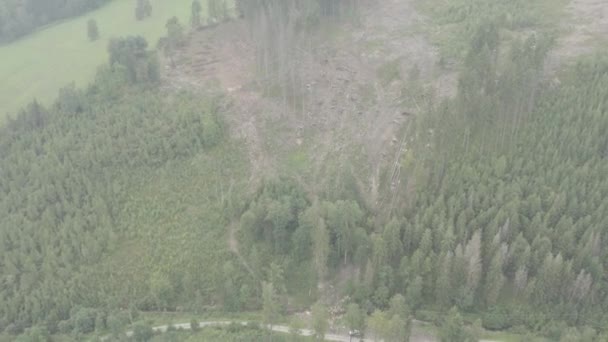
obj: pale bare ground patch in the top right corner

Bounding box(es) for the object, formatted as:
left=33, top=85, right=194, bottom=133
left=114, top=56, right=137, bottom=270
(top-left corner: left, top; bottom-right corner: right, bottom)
left=546, top=0, right=608, bottom=74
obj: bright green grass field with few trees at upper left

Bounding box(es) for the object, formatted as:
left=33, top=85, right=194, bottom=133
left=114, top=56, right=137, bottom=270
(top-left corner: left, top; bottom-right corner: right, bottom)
left=0, top=0, right=197, bottom=124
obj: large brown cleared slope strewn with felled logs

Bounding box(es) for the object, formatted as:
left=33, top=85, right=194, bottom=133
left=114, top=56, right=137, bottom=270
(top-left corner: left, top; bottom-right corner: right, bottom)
left=165, top=0, right=455, bottom=214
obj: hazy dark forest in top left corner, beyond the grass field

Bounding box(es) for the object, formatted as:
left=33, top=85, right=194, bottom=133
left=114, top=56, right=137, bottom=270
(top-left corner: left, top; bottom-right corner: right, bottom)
left=0, top=0, right=108, bottom=43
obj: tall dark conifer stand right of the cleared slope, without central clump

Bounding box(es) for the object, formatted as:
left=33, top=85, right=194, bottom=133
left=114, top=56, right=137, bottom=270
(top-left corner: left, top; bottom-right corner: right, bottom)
left=388, top=25, right=608, bottom=336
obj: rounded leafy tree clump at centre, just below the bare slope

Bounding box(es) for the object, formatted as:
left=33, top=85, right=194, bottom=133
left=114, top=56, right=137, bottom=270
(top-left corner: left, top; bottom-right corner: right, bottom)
left=240, top=179, right=369, bottom=300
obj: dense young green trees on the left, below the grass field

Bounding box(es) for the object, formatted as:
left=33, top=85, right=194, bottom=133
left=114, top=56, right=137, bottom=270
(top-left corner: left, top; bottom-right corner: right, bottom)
left=0, top=44, right=223, bottom=333
